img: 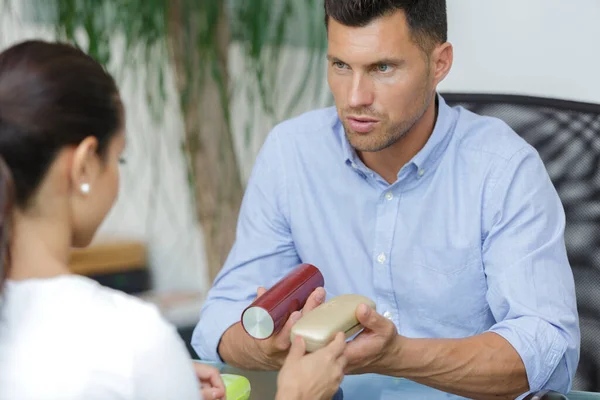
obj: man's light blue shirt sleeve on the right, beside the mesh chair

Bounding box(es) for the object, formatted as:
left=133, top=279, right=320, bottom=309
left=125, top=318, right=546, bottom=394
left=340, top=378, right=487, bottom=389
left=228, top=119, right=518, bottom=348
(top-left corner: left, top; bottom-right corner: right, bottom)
left=482, top=146, right=580, bottom=393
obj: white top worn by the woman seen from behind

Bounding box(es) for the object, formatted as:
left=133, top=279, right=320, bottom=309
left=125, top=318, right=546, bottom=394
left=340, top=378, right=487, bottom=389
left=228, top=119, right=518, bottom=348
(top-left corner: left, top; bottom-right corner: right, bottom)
left=0, top=275, right=201, bottom=400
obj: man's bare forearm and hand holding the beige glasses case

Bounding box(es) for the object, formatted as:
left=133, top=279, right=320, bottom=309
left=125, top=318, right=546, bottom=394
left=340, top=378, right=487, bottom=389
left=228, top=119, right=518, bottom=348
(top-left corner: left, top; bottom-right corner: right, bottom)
left=344, top=304, right=530, bottom=400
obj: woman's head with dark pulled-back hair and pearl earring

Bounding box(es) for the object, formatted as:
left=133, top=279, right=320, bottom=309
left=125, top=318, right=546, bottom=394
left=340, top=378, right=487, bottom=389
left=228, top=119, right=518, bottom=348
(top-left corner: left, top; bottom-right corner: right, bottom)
left=0, top=41, right=125, bottom=252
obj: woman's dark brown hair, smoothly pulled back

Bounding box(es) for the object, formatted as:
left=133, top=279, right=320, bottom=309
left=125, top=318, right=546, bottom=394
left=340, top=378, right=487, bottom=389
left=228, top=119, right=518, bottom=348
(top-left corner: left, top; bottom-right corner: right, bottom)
left=0, top=40, right=123, bottom=284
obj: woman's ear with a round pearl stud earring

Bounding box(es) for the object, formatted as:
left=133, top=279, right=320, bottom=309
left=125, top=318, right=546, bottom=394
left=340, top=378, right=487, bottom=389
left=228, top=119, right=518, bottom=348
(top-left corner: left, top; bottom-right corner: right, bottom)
left=71, top=136, right=102, bottom=195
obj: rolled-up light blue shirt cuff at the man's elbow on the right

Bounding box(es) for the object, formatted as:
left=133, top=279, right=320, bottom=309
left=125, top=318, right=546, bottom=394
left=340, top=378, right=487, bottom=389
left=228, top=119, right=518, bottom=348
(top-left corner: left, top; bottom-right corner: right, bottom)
left=489, top=317, right=567, bottom=392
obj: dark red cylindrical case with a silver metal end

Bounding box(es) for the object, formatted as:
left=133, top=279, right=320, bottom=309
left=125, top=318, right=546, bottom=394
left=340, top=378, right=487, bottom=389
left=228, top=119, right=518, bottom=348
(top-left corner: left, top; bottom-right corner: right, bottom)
left=241, top=264, right=325, bottom=339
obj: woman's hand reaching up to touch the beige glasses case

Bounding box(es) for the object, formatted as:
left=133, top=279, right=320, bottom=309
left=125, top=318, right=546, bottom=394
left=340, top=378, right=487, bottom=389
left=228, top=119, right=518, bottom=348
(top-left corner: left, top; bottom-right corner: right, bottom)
left=277, top=333, right=346, bottom=400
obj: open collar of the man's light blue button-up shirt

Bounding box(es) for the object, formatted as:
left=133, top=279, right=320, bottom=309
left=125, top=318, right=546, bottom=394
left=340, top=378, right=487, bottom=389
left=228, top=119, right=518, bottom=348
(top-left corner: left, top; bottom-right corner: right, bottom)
left=335, top=94, right=455, bottom=176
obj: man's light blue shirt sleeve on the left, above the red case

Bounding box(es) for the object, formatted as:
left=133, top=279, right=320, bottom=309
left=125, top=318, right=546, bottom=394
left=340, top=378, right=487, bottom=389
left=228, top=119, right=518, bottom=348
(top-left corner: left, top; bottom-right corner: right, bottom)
left=192, top=126, right=300, bottom=361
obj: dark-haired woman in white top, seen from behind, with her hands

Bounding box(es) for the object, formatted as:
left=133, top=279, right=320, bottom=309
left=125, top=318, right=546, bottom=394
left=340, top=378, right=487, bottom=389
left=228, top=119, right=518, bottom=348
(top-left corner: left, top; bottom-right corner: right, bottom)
left=0, top=41, right=344, bottom=400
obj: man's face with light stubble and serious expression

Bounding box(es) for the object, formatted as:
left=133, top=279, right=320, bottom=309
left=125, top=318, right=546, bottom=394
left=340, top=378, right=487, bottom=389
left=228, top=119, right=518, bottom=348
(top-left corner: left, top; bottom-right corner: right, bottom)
left=327, top=11, right=434, bottom=152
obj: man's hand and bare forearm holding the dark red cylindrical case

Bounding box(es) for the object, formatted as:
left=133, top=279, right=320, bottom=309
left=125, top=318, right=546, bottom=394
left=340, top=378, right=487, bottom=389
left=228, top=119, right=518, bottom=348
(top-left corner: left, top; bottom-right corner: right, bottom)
left=218, top=287, right=325, bottom=370
